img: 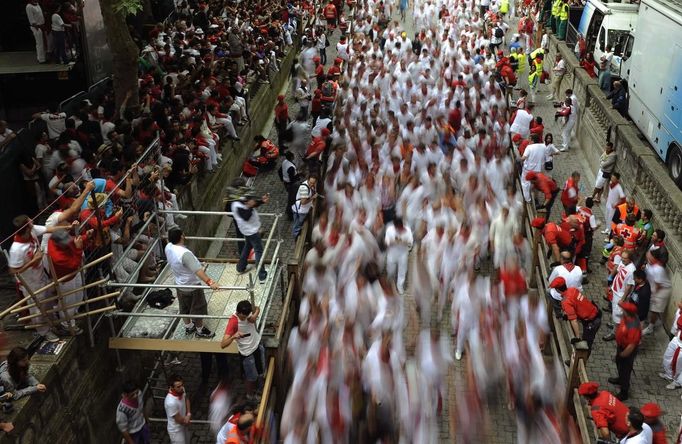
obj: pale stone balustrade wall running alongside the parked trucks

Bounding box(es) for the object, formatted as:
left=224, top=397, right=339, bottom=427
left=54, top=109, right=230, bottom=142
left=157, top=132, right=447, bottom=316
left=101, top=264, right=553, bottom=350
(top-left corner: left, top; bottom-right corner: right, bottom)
left=547, top=36, right=682, bottom=327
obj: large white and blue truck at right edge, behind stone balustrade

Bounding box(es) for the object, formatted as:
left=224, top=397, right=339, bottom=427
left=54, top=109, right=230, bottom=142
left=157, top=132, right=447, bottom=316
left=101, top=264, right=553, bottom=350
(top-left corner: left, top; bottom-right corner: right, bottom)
left=614, top=0, right=682, bottom=187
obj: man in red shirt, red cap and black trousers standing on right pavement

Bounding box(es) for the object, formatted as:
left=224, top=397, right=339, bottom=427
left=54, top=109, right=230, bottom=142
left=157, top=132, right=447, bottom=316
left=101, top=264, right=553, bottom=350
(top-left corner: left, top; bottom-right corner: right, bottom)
left=609, top=302, right=642, bottom=401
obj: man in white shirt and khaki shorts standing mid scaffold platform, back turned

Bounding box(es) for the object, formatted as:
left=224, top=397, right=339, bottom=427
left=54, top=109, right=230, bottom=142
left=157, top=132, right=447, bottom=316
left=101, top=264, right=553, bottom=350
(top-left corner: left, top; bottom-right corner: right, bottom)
left=164, top=228, right=218, bottom=338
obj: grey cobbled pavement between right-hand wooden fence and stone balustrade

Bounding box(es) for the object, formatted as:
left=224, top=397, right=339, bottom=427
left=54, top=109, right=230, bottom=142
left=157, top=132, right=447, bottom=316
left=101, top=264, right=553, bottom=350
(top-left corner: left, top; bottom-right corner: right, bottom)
left=534, top=50, right=682, bottom=439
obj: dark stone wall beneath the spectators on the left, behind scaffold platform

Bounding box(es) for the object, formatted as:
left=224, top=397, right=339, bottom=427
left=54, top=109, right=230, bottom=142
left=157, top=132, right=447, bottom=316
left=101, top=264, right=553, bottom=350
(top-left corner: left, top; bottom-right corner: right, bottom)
left=0, top=44, right=298, bottom=444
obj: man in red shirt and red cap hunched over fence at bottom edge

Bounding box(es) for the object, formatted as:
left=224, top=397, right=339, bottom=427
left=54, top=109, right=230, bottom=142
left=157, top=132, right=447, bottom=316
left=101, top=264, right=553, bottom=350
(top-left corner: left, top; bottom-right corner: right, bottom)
left=578, top=381, right=630, bottom=439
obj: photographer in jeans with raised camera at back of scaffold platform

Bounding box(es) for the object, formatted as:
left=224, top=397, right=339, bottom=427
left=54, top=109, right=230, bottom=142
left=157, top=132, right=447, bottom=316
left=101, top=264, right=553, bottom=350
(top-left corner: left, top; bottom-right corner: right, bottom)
left=232, top=194, right=270, bottom=282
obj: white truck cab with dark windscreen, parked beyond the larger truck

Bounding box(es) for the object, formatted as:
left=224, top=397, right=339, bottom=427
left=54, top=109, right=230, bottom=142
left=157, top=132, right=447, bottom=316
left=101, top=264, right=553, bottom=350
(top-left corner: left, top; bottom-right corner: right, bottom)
left=578, top=0, right=639, bottom=78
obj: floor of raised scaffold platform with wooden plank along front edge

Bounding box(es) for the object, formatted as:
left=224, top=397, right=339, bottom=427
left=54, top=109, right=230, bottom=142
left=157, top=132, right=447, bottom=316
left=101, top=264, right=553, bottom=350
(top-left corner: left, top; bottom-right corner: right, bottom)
left=109, top=262, right=278, bottom=353
